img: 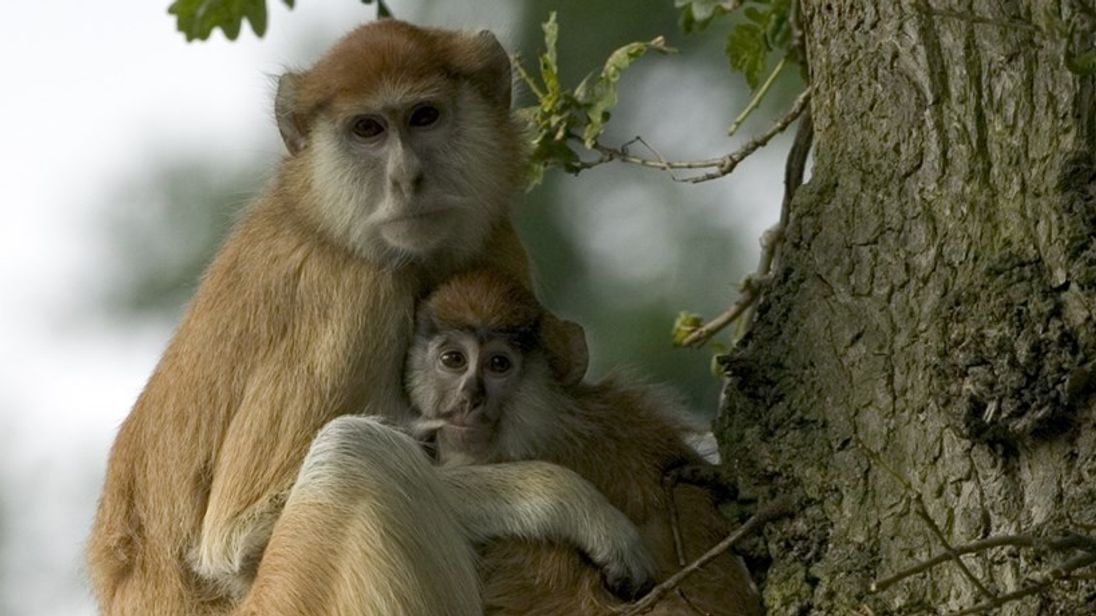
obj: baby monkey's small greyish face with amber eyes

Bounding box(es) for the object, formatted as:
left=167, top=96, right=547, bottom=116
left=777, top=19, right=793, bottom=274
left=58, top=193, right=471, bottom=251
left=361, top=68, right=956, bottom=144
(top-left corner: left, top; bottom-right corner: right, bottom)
left=409, top=331, right=526, bottom=461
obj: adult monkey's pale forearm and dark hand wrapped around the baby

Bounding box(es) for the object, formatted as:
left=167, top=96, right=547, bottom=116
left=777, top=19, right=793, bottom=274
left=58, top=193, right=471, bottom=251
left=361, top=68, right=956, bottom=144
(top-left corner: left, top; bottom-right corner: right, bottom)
left=439, top=461, right=657, bottom=596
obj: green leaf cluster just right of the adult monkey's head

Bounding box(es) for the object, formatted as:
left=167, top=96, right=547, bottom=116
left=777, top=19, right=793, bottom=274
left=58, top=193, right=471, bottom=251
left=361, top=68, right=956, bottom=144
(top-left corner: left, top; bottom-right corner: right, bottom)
left=515, top=12, right=674, bottom=185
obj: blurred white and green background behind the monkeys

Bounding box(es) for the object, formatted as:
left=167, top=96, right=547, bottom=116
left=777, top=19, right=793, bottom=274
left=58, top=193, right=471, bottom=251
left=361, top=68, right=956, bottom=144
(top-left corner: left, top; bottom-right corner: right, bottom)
left=0, top=0, right=792, bottom=615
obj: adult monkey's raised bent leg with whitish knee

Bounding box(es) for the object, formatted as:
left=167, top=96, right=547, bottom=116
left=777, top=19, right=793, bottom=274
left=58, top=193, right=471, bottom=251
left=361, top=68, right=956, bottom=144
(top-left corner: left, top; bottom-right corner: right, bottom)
left=235, top=417, right=483, bottom=616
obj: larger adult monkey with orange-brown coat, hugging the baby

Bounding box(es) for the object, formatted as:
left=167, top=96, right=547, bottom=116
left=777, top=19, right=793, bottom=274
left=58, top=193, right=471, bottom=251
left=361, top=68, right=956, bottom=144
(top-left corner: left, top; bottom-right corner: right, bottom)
left=88, top=20, right=650, bottom=616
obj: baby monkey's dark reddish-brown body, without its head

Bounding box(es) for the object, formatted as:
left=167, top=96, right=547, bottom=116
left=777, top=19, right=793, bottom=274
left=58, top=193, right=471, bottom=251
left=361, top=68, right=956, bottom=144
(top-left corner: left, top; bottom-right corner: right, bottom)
left=481, top=377, right=762, bottom=616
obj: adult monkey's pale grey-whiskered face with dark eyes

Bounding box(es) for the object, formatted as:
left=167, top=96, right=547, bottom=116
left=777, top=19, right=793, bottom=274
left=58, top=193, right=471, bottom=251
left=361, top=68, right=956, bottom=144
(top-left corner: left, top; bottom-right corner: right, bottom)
left=310, top=79, right=510, bottom=261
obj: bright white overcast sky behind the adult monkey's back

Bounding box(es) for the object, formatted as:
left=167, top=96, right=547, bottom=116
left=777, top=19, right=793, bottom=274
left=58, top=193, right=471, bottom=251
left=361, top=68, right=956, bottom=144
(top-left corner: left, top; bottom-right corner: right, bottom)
left=0, top=0, right=789, bottom=616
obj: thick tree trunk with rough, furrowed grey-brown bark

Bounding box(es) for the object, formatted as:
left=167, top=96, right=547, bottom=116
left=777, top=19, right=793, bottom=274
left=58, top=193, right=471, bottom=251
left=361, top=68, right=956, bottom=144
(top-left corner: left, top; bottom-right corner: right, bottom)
left=718, top=0, right=1096, bottom=615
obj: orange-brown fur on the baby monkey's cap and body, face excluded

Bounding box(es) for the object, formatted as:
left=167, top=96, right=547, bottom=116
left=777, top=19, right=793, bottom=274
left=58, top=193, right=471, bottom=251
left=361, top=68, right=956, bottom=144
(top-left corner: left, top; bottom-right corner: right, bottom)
left=411, top=271, right=762, bottom=616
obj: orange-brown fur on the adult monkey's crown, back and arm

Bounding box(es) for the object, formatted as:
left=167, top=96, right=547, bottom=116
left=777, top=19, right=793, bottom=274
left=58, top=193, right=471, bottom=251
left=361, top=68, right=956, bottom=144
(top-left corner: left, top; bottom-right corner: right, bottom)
left=88, top=22, right=528, bottom=616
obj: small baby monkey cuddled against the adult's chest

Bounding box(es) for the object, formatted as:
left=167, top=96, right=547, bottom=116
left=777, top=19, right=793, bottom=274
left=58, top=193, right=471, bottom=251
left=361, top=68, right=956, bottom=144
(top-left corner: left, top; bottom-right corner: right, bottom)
left=408, top=271, right=762, bottom=616
